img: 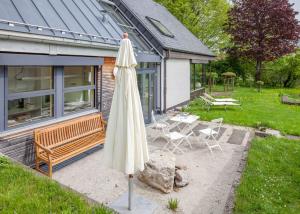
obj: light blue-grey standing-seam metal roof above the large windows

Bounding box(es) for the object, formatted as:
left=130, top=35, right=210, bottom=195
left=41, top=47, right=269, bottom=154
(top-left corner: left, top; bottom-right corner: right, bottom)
left=0, top=0, right=155, bottom=52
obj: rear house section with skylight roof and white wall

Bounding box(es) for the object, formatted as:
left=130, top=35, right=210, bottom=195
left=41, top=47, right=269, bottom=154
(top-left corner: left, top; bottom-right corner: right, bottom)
left=112, top=0, right=215, bottom=108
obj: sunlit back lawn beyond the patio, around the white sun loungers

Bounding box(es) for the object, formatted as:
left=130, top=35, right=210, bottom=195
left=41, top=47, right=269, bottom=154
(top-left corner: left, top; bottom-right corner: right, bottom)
left=186, top=88, right=300, bottom=135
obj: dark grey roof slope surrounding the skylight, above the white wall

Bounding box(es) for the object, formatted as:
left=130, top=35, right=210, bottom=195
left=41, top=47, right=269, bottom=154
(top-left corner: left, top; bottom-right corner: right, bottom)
left=112, top=0, right=214, bottom=56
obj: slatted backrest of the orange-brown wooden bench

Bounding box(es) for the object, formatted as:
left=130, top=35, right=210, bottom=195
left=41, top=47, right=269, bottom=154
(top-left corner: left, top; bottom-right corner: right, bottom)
left=34, top=114, right=105, bottom=149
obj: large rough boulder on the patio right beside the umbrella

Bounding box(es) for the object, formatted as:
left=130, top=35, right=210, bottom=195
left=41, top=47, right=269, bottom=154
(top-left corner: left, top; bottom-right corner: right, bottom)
left=138, top=151, right=176, bottom=193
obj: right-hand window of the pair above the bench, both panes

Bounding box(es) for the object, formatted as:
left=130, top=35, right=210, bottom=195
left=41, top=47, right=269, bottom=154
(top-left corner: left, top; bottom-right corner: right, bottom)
left=64, top=66, right=95, bottom=114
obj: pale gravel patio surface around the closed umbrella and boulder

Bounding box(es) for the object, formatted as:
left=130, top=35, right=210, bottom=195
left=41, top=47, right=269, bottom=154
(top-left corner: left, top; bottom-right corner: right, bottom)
left=53, top=117, right=254, bottom=214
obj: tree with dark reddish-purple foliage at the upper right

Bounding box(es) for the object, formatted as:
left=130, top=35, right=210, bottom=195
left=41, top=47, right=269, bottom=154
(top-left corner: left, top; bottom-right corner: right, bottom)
left=227, top=0, right=300, bottom=81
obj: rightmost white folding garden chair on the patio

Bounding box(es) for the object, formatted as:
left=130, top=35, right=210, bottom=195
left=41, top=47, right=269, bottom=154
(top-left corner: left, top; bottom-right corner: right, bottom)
left=199, top=118, right=223, bottom=153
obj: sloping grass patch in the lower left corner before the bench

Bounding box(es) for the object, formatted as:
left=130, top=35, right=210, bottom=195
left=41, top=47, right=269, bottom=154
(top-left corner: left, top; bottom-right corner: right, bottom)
left=0, top=157, right=113, bottom=214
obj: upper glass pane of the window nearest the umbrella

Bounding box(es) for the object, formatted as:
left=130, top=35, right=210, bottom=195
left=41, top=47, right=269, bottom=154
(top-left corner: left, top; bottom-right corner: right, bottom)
left=64, top=66, right=94, bottom=88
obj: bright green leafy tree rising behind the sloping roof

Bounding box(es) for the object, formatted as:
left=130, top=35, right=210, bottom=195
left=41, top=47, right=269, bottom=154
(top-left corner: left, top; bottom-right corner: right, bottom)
left=156, top=0, right=230, bottom=54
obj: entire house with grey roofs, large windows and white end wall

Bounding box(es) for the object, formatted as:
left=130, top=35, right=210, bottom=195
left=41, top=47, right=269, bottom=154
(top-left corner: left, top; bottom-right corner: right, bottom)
left=0, top=0, right=214, bottom=165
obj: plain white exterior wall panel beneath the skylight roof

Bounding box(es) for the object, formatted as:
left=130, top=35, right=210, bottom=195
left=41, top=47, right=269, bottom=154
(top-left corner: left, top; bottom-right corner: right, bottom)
left=166, top=59, right=190, bottom=109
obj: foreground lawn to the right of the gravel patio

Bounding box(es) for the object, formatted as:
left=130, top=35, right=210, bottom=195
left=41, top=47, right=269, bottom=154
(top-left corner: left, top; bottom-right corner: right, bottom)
left=234, top=138, right=300, bottom=214
